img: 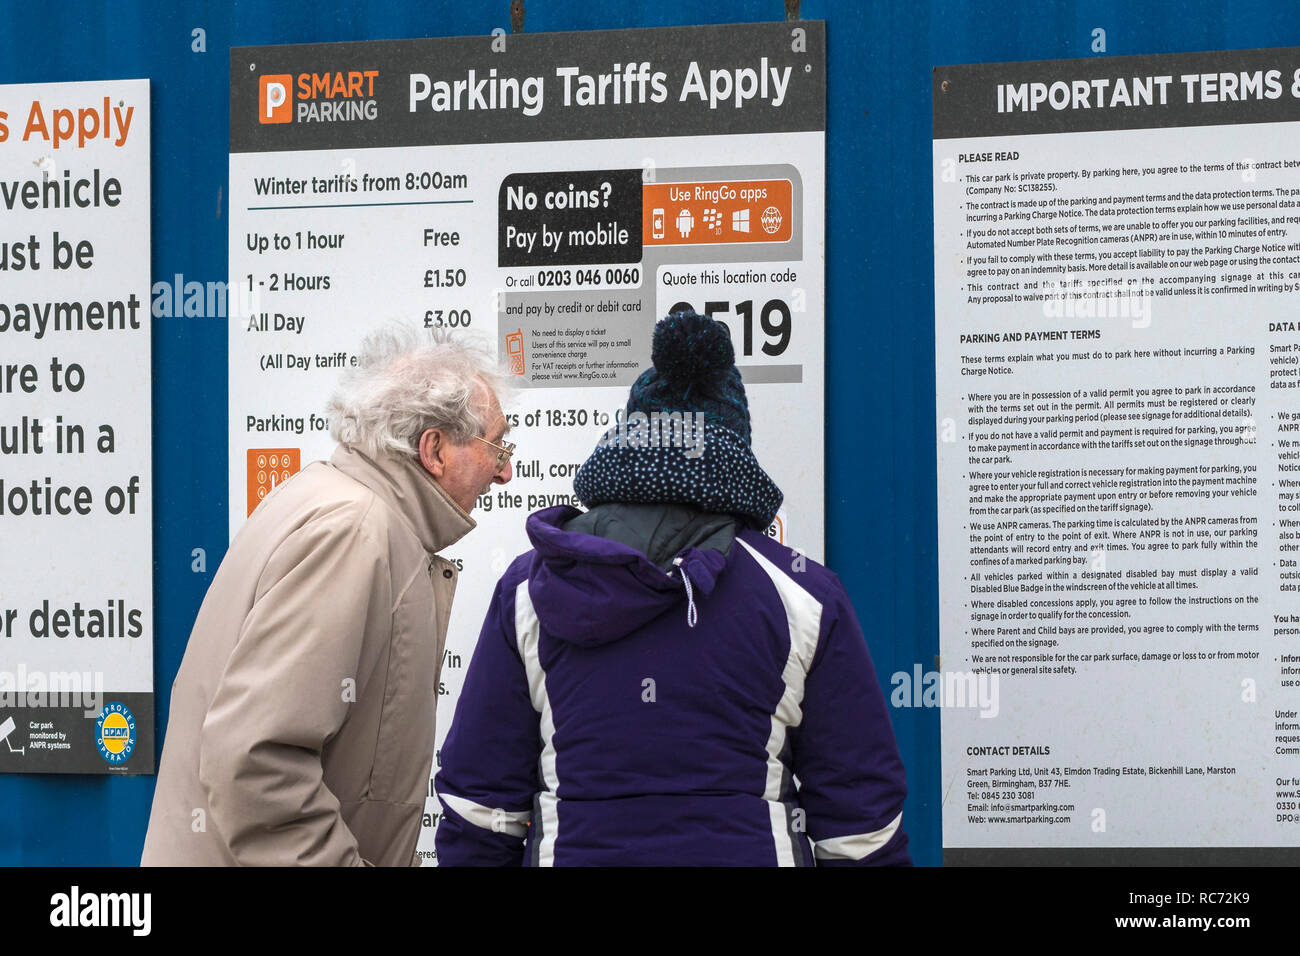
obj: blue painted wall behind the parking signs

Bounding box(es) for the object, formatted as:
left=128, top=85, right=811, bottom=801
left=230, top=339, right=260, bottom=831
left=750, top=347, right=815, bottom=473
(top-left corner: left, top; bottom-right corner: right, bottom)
left=0, top=0, right=1300, bottom=865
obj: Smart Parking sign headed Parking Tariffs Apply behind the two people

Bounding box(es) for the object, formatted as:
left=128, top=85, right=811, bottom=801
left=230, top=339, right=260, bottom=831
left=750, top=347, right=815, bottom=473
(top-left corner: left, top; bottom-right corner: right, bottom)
left=229, top=21, right=826, bottom=860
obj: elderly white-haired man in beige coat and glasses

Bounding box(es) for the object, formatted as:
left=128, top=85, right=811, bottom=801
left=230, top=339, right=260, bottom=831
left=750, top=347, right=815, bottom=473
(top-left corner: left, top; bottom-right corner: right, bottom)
left=142, top=332, right=514, bottom=866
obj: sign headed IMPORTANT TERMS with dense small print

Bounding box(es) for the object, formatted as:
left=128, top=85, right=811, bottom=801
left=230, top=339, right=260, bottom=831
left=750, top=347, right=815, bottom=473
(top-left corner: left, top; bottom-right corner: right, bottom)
left=935, top=49, right=1300, bottom=864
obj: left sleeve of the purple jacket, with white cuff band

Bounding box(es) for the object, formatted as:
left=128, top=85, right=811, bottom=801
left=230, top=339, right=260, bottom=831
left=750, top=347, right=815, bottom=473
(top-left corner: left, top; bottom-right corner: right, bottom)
left=434, top=571, right=541, bottom=866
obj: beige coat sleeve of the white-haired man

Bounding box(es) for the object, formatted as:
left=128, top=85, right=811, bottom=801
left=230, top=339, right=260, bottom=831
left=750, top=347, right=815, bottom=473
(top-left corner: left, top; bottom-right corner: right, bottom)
left=199, top=514, right=393, bottom=866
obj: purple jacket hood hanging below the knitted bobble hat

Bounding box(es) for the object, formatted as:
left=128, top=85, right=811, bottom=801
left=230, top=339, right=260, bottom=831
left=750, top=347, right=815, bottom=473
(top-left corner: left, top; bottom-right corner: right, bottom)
left=527, top=505, right=732, bottom=646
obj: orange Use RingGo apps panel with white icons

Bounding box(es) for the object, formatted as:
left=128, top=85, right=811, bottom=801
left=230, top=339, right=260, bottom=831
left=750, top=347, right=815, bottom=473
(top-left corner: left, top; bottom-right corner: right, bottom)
left=641, top=179, right=794, bottom=246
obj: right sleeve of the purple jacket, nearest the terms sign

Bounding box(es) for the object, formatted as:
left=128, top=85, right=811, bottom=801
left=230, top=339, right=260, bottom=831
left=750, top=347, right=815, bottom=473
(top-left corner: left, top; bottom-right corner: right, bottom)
left=794, top=579, right=911, bottom=866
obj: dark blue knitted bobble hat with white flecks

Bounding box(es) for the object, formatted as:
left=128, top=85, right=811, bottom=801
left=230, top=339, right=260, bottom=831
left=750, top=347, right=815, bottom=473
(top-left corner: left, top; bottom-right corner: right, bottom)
left=573, top=310, right=781, bottom=528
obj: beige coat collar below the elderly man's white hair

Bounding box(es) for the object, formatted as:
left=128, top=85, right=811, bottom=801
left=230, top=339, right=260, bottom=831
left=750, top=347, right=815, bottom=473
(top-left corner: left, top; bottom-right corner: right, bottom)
left=330, top=445, right=476, bottom=554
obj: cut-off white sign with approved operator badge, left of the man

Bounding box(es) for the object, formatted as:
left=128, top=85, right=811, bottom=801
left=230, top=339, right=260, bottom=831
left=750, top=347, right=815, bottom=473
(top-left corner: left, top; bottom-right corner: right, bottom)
left=0, top=79, right=153, bottom=774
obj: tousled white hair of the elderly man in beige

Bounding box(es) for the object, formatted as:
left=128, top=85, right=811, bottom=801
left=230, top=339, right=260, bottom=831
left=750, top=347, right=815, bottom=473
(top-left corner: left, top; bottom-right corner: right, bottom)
left=326, top=325, right=506, bottom=458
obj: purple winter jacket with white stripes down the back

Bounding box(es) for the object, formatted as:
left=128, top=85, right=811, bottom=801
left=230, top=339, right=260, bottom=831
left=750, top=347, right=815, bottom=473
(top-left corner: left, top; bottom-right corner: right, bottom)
left=434, top=506, right=910, bottom=866
